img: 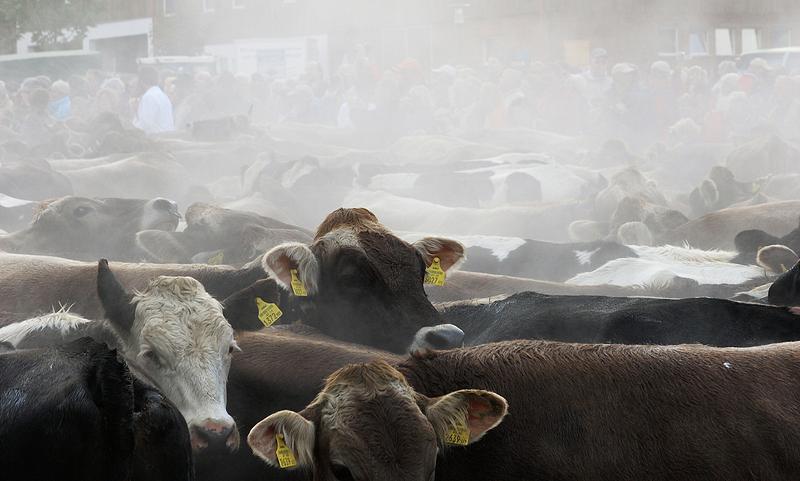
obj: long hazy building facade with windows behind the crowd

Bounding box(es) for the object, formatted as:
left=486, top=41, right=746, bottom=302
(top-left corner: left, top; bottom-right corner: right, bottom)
left=153, top=0, right=800, bottom=75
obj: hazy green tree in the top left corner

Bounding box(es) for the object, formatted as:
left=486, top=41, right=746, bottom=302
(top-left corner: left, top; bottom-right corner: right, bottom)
left=0, top=0, right=105, bottom=50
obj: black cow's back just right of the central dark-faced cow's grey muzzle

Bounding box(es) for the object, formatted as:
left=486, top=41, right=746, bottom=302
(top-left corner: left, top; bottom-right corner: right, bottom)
left=439, top=292, right=800, bottom=347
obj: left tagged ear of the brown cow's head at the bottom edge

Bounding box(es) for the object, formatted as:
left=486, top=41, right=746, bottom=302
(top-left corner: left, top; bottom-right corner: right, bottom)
left=247, top=411, right=315, bottom=469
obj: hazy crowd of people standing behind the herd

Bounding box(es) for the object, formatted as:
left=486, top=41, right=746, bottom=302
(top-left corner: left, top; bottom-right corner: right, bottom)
left=0, top=48, right=800, bottom=153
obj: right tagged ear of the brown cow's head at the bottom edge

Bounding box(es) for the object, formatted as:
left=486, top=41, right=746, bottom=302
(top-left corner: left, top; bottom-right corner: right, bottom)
left=426, top=389, right=508, bottom=444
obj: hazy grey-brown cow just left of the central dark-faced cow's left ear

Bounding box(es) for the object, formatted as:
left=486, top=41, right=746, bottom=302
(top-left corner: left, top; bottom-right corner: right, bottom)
left=136, top=202, right=312, bottom=265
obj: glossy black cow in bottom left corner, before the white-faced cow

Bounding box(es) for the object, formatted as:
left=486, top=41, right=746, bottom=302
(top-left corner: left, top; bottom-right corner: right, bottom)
left=0, top=339, right=194, bottom=481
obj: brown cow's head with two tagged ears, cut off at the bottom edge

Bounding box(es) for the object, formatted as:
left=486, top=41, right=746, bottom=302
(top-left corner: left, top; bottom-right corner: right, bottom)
left=247, top=361, right=508, bottom=481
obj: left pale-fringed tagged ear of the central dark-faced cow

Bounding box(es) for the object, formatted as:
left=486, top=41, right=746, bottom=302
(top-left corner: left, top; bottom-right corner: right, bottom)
left=262, top=242, right=319, bottom=295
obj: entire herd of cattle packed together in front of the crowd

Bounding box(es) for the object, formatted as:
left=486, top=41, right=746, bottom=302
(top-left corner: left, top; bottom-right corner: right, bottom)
left=0, top=124, right=800, bottom=481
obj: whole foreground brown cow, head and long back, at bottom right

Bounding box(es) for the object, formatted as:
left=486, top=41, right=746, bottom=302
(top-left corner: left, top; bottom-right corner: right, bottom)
left=248, top=341, right=800, bottom=481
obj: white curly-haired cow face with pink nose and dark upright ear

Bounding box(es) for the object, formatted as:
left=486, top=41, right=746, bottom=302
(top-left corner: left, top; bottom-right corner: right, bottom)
left=97, top=261, right=239, bottom=451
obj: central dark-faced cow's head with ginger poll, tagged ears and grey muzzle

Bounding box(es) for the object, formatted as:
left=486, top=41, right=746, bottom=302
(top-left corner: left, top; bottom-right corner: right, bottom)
left=263, top=209, right=464, bottom=352
